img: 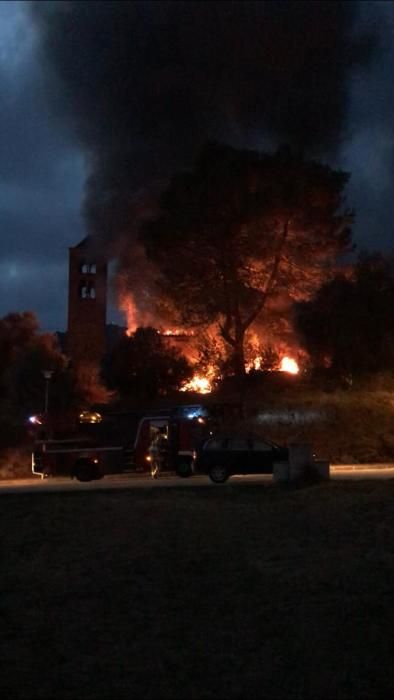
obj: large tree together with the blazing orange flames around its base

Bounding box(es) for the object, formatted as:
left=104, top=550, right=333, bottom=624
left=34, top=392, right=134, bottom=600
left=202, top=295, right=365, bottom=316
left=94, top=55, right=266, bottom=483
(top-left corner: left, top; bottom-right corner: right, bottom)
left=111, top=144, right=353, bottom=392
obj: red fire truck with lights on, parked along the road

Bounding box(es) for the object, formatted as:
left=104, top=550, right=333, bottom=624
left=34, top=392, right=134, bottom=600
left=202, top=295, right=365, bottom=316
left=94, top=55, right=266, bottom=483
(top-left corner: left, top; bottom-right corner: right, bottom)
left=32, top=406, right=211, bottom=481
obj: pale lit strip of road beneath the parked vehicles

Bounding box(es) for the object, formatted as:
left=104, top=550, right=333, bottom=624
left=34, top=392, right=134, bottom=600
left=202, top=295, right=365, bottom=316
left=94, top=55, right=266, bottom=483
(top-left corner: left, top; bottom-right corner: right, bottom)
left=0, top=464, right=394, bottom=495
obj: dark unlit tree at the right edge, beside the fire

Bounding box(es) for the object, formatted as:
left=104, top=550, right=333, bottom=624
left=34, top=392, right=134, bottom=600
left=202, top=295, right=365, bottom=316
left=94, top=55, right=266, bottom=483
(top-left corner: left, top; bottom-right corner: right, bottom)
left=294, top=254, right=394, bottom=377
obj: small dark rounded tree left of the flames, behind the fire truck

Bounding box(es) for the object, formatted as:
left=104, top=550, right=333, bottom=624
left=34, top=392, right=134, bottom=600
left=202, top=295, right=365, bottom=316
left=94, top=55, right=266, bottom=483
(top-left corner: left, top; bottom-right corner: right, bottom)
left=104, top=327, right=192, bottom=398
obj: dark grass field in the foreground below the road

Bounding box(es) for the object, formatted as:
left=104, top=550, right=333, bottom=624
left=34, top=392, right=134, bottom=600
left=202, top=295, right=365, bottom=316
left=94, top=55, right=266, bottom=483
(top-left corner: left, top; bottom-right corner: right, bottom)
left=0, top=481, right=394, bottom=700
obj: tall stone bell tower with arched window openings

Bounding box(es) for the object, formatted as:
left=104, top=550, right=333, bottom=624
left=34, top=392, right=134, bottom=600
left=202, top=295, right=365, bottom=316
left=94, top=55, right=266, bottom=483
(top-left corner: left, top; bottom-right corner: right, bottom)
left=66, top=236, right=107, bottom=368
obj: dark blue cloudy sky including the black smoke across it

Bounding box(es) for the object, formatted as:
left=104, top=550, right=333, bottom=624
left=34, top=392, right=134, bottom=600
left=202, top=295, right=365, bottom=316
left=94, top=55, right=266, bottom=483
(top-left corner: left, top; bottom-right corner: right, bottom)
left=0, top=0, right=394, bottom=330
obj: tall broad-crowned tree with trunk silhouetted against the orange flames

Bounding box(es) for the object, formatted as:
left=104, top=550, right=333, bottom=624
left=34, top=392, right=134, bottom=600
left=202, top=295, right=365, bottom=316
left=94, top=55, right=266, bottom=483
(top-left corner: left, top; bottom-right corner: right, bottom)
left=141, top=139, right=353, bottom=375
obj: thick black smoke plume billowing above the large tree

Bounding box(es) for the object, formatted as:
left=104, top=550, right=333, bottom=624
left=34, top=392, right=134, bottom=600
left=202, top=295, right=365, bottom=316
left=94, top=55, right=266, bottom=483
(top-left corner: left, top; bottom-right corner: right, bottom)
left=32, top=0, right=375, bottom=238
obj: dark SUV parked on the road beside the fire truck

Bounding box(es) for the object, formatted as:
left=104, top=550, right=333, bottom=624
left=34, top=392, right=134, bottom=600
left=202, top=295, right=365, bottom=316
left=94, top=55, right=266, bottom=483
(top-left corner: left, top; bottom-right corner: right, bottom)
left=195, top=436, right=289, bottom=484
